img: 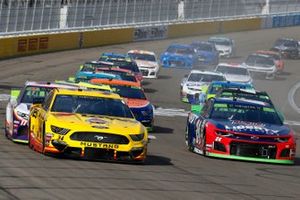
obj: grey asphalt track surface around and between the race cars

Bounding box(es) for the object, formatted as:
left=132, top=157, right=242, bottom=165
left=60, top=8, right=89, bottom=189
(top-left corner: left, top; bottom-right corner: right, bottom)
left=0, top=27, right=300, bottom=200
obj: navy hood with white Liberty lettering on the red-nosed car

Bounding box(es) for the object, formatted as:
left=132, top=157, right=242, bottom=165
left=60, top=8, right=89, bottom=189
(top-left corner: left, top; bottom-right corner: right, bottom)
left=213, top=120, right=290, bottom=136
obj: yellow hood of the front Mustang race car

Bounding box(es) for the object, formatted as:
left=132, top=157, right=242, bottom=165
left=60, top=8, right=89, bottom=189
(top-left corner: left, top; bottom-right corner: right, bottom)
left=48, top=113, right=141, bottom=133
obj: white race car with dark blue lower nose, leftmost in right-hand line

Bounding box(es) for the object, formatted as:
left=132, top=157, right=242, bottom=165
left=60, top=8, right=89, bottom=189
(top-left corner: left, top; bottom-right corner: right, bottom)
left=180, top=70, right=225, bottom=104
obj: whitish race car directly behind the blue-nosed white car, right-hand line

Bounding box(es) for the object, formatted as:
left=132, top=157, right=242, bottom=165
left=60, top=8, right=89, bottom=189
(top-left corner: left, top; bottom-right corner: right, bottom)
left=215, top=63, right=253, bottom=83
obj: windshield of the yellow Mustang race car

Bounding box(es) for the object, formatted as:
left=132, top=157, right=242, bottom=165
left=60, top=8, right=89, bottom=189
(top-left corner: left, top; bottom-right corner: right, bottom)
left=51, top=95, right=133, bottom=118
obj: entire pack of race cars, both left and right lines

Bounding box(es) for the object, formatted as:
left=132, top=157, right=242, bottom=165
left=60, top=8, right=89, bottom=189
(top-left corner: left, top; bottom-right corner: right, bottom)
left=5, top=37, right=296, bottom=164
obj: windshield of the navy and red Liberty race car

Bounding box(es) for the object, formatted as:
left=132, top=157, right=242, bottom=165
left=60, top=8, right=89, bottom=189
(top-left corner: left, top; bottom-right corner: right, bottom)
left=210, top=103, right=282, bottom=125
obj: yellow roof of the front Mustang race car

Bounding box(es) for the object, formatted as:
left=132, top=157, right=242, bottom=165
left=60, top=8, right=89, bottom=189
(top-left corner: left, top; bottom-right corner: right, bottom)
left=54, top=88, right=122, bottom=99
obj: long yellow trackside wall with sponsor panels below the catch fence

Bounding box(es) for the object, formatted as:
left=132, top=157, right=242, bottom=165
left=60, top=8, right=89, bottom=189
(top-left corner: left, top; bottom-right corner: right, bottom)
left=0, top=14, right=300, bottom=59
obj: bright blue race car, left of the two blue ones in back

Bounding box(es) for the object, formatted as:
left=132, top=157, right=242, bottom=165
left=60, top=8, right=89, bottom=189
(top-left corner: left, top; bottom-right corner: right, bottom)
left=160, top=44, right=198, bottom=68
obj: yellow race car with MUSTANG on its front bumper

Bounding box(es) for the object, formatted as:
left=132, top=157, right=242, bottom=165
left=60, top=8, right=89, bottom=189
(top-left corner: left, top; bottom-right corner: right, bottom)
left=28, top=89, right=148, bottom=162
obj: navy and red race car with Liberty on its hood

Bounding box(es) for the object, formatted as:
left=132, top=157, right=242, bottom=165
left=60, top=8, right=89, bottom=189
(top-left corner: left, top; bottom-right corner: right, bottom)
left=185, top=98, right=296, bottom=164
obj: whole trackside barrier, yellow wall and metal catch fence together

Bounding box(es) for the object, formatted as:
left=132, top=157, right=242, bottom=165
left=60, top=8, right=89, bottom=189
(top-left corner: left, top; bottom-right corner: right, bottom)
left=0, top=0, right=300, bottom=59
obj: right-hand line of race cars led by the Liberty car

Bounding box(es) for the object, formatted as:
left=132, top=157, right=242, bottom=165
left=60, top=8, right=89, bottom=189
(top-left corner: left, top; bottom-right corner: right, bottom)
left=180, top=39, right=296, bottom=164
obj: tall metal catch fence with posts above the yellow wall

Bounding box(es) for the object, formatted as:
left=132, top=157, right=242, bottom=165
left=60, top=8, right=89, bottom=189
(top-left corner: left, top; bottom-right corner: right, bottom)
left=0, top=0, right=300, bottom=36
